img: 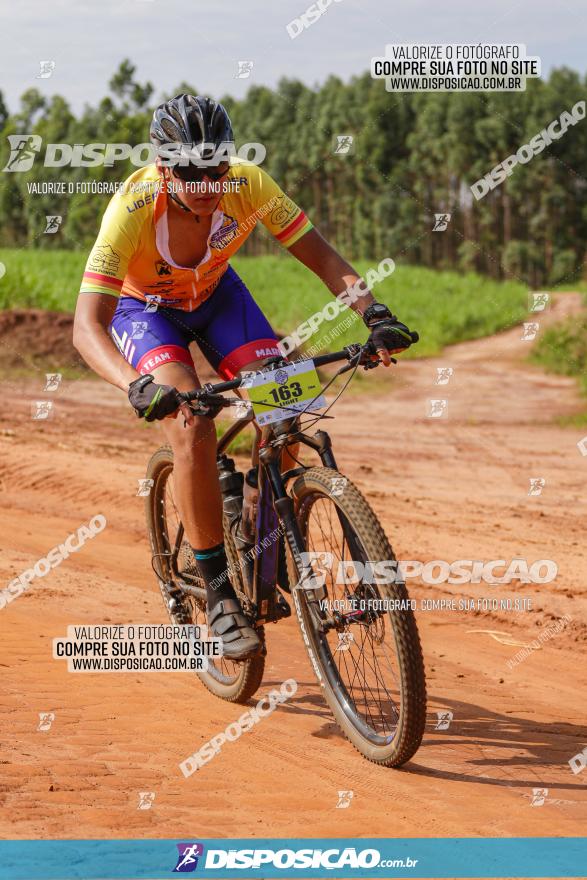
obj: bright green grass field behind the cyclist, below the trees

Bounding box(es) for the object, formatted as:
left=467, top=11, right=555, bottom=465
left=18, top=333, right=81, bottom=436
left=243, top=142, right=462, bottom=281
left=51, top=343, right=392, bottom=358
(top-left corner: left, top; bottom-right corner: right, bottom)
left=0, top=249, right=528, bottom=357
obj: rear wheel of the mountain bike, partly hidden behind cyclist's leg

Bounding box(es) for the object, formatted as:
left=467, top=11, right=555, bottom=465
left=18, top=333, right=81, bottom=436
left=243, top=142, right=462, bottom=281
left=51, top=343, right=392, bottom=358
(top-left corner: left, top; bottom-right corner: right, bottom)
left=145, top=446, right=265, bottom=703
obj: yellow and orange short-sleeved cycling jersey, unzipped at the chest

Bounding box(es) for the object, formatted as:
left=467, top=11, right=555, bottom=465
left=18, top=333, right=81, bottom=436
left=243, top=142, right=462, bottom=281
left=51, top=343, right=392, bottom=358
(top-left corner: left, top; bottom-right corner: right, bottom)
left=81, top=160, right=312, bottom=311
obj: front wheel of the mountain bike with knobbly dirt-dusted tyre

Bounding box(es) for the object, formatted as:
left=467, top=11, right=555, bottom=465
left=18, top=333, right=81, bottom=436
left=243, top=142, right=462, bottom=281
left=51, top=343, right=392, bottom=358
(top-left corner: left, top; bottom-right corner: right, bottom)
left=288, top=468, right=426, bottom=767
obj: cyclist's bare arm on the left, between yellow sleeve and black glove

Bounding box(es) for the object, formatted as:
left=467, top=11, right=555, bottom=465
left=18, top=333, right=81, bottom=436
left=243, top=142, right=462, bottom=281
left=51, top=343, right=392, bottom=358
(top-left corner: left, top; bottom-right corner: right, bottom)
left=73, top=293, right=139, bottom=391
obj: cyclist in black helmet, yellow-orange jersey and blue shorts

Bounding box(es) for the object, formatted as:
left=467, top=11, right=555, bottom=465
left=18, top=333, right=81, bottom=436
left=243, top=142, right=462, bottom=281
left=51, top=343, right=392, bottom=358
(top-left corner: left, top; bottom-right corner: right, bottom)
left=73, top=94, right=411, bottom=659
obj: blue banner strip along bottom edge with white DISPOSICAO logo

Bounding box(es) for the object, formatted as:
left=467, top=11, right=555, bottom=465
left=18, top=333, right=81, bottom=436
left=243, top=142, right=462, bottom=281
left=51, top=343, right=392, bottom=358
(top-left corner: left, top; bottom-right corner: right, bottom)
left=0, top=837, right=587, bottom=880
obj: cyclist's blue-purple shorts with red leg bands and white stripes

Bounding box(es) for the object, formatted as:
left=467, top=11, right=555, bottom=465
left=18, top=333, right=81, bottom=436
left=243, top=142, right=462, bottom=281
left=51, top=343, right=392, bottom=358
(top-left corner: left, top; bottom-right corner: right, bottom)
left=110, top=266, right=280, bottom=379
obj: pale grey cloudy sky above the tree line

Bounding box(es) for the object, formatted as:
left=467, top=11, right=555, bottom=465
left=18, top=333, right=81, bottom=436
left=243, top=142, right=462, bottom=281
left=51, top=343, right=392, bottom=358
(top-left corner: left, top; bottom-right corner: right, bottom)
left=0, top=0, right=587, bottom=112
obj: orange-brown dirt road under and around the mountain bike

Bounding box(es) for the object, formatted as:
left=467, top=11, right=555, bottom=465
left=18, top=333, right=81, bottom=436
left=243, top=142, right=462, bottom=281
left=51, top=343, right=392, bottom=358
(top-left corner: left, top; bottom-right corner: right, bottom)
left=0, top=295, right=587, bottom=839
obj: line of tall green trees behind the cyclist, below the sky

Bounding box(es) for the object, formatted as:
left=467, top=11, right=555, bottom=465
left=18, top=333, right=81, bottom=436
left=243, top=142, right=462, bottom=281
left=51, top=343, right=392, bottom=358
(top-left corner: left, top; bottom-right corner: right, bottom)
left=0, top=60, right=587, bottom=287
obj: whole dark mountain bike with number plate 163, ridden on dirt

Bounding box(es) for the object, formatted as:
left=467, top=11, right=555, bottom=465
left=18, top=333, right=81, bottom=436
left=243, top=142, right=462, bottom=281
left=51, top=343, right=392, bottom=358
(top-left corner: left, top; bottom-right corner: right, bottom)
left=145, top=343, right=426, bottom=767
